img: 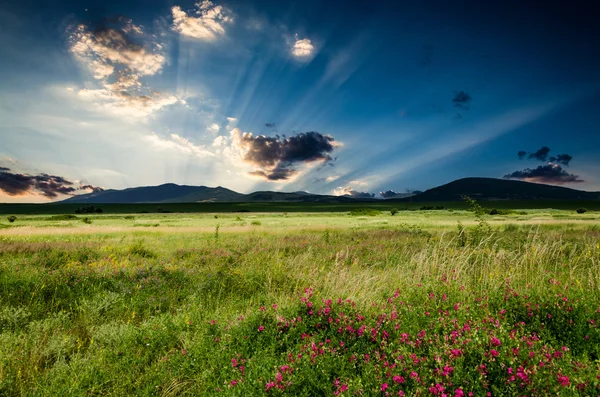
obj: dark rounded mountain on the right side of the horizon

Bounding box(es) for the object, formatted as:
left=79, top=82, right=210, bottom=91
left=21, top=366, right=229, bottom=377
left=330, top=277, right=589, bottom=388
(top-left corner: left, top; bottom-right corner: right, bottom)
left=398, top=178, right=600, bottom=202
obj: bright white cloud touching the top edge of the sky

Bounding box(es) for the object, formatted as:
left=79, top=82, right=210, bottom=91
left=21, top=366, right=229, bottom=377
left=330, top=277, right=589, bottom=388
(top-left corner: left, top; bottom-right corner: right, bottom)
left=171, top=0, right=233, bottom=41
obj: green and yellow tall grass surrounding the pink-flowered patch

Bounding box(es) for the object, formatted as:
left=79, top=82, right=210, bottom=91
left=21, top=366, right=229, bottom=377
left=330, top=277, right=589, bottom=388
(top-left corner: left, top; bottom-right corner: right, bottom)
left=0, top=226, right=600, bottom=396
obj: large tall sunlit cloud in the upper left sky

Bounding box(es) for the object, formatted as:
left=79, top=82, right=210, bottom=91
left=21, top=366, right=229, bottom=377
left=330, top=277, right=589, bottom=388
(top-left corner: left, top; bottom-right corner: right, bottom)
left=69, top=18, right=177, bottom=117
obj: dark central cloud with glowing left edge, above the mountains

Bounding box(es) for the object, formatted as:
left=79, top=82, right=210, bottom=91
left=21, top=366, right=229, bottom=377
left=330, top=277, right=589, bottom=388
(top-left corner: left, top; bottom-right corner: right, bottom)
left=236, top=131, right=337, bottom=181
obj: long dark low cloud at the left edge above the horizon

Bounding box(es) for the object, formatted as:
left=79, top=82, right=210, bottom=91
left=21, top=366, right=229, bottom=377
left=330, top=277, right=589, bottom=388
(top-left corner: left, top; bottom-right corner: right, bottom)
left=0, top=167, right=103, bottom=199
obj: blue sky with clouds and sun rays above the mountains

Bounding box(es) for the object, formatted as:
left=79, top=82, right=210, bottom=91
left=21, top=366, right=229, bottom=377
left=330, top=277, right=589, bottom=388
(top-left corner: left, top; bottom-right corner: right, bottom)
left=0, top=0, right=600, bottom=202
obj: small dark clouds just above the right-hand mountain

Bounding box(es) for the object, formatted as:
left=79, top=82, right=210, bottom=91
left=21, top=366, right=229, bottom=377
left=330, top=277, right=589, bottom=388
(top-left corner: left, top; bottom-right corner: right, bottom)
left=504, top=146, right=584, bottom=185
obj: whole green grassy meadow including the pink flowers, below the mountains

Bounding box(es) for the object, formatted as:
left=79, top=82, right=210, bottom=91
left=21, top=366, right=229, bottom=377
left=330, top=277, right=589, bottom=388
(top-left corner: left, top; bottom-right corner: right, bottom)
left=0, top=209, right=600, bottom=397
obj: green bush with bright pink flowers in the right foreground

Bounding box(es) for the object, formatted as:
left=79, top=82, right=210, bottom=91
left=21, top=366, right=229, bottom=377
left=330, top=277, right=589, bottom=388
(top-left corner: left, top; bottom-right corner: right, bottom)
left=199, top=282, right=600, bottom=397
